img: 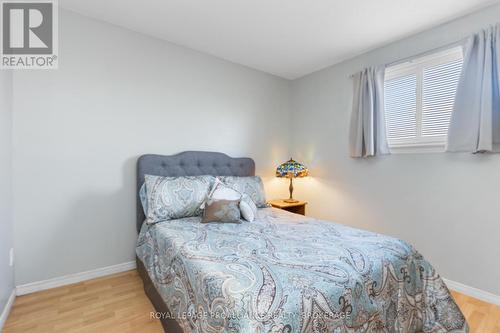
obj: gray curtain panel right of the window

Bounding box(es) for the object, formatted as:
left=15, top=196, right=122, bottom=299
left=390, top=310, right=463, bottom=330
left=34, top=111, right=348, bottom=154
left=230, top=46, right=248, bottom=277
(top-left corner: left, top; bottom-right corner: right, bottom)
left=447, top=25, right=500, bottom=153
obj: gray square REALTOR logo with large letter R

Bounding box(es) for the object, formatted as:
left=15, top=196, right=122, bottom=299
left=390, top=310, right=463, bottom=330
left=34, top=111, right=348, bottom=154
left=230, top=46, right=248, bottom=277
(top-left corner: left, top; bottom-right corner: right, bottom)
left=0, top=0, right=57, bottom=69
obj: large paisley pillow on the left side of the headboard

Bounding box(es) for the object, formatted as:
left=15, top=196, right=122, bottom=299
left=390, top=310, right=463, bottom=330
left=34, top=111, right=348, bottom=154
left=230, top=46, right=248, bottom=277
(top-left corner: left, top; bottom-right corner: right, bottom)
left=145, top=175, right=215, bottom=223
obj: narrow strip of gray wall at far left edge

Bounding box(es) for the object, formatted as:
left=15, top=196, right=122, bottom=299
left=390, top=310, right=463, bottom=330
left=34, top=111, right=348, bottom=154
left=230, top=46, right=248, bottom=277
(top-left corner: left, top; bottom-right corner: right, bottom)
left=0, top=70, right=14, bottom=313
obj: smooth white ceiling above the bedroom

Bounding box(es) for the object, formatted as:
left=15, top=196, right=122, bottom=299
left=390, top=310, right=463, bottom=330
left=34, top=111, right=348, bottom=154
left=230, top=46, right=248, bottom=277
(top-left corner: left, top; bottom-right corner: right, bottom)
left=59, top=0, right=498, bottom=79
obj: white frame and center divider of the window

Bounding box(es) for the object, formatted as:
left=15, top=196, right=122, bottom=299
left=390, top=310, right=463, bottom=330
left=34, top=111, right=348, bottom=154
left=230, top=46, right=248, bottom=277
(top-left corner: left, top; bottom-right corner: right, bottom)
left=384, top=46, right=463, bottom=153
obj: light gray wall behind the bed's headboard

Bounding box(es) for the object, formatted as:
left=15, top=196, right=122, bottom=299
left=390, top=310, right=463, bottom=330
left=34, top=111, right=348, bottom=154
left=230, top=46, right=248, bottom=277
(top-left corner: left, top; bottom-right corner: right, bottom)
left=14, top=10, right=290, bottom=284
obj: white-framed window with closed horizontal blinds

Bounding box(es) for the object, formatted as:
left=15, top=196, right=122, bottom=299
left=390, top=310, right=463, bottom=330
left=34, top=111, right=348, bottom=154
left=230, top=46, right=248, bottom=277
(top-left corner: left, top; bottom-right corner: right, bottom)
left=385, top=47, right=463, bottom=152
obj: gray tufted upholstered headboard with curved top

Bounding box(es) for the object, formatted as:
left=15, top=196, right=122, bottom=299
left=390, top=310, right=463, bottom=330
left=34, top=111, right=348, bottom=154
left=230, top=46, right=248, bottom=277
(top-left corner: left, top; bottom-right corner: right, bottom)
left=136, top=151, right=255, bottom=232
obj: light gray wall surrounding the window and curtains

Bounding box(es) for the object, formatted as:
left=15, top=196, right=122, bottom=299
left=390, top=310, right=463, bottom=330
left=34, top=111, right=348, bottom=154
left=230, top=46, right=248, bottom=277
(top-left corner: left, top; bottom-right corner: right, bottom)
left=291, top=5, right=500, bottom=295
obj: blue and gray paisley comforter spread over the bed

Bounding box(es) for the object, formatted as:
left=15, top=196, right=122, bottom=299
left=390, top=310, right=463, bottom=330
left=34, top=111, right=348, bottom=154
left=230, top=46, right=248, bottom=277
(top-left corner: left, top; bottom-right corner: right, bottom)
left=136, top=208, right=468, bottom=333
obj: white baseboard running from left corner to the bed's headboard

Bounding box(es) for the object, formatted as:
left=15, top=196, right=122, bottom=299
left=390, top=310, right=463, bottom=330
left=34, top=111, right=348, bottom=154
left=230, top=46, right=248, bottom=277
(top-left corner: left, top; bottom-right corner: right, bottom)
left=16, top=261, right=136, bottom=296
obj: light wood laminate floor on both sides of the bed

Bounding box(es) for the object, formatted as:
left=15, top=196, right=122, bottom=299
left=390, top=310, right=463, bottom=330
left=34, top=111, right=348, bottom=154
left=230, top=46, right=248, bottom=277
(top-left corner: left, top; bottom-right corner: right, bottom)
left=4, top=271, right=500, bottom=333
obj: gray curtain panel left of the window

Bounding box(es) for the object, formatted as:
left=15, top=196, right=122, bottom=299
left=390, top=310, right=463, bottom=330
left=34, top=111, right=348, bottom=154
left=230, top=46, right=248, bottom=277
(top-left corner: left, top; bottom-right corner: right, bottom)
left=349, top=66, right=389, bottom=157
